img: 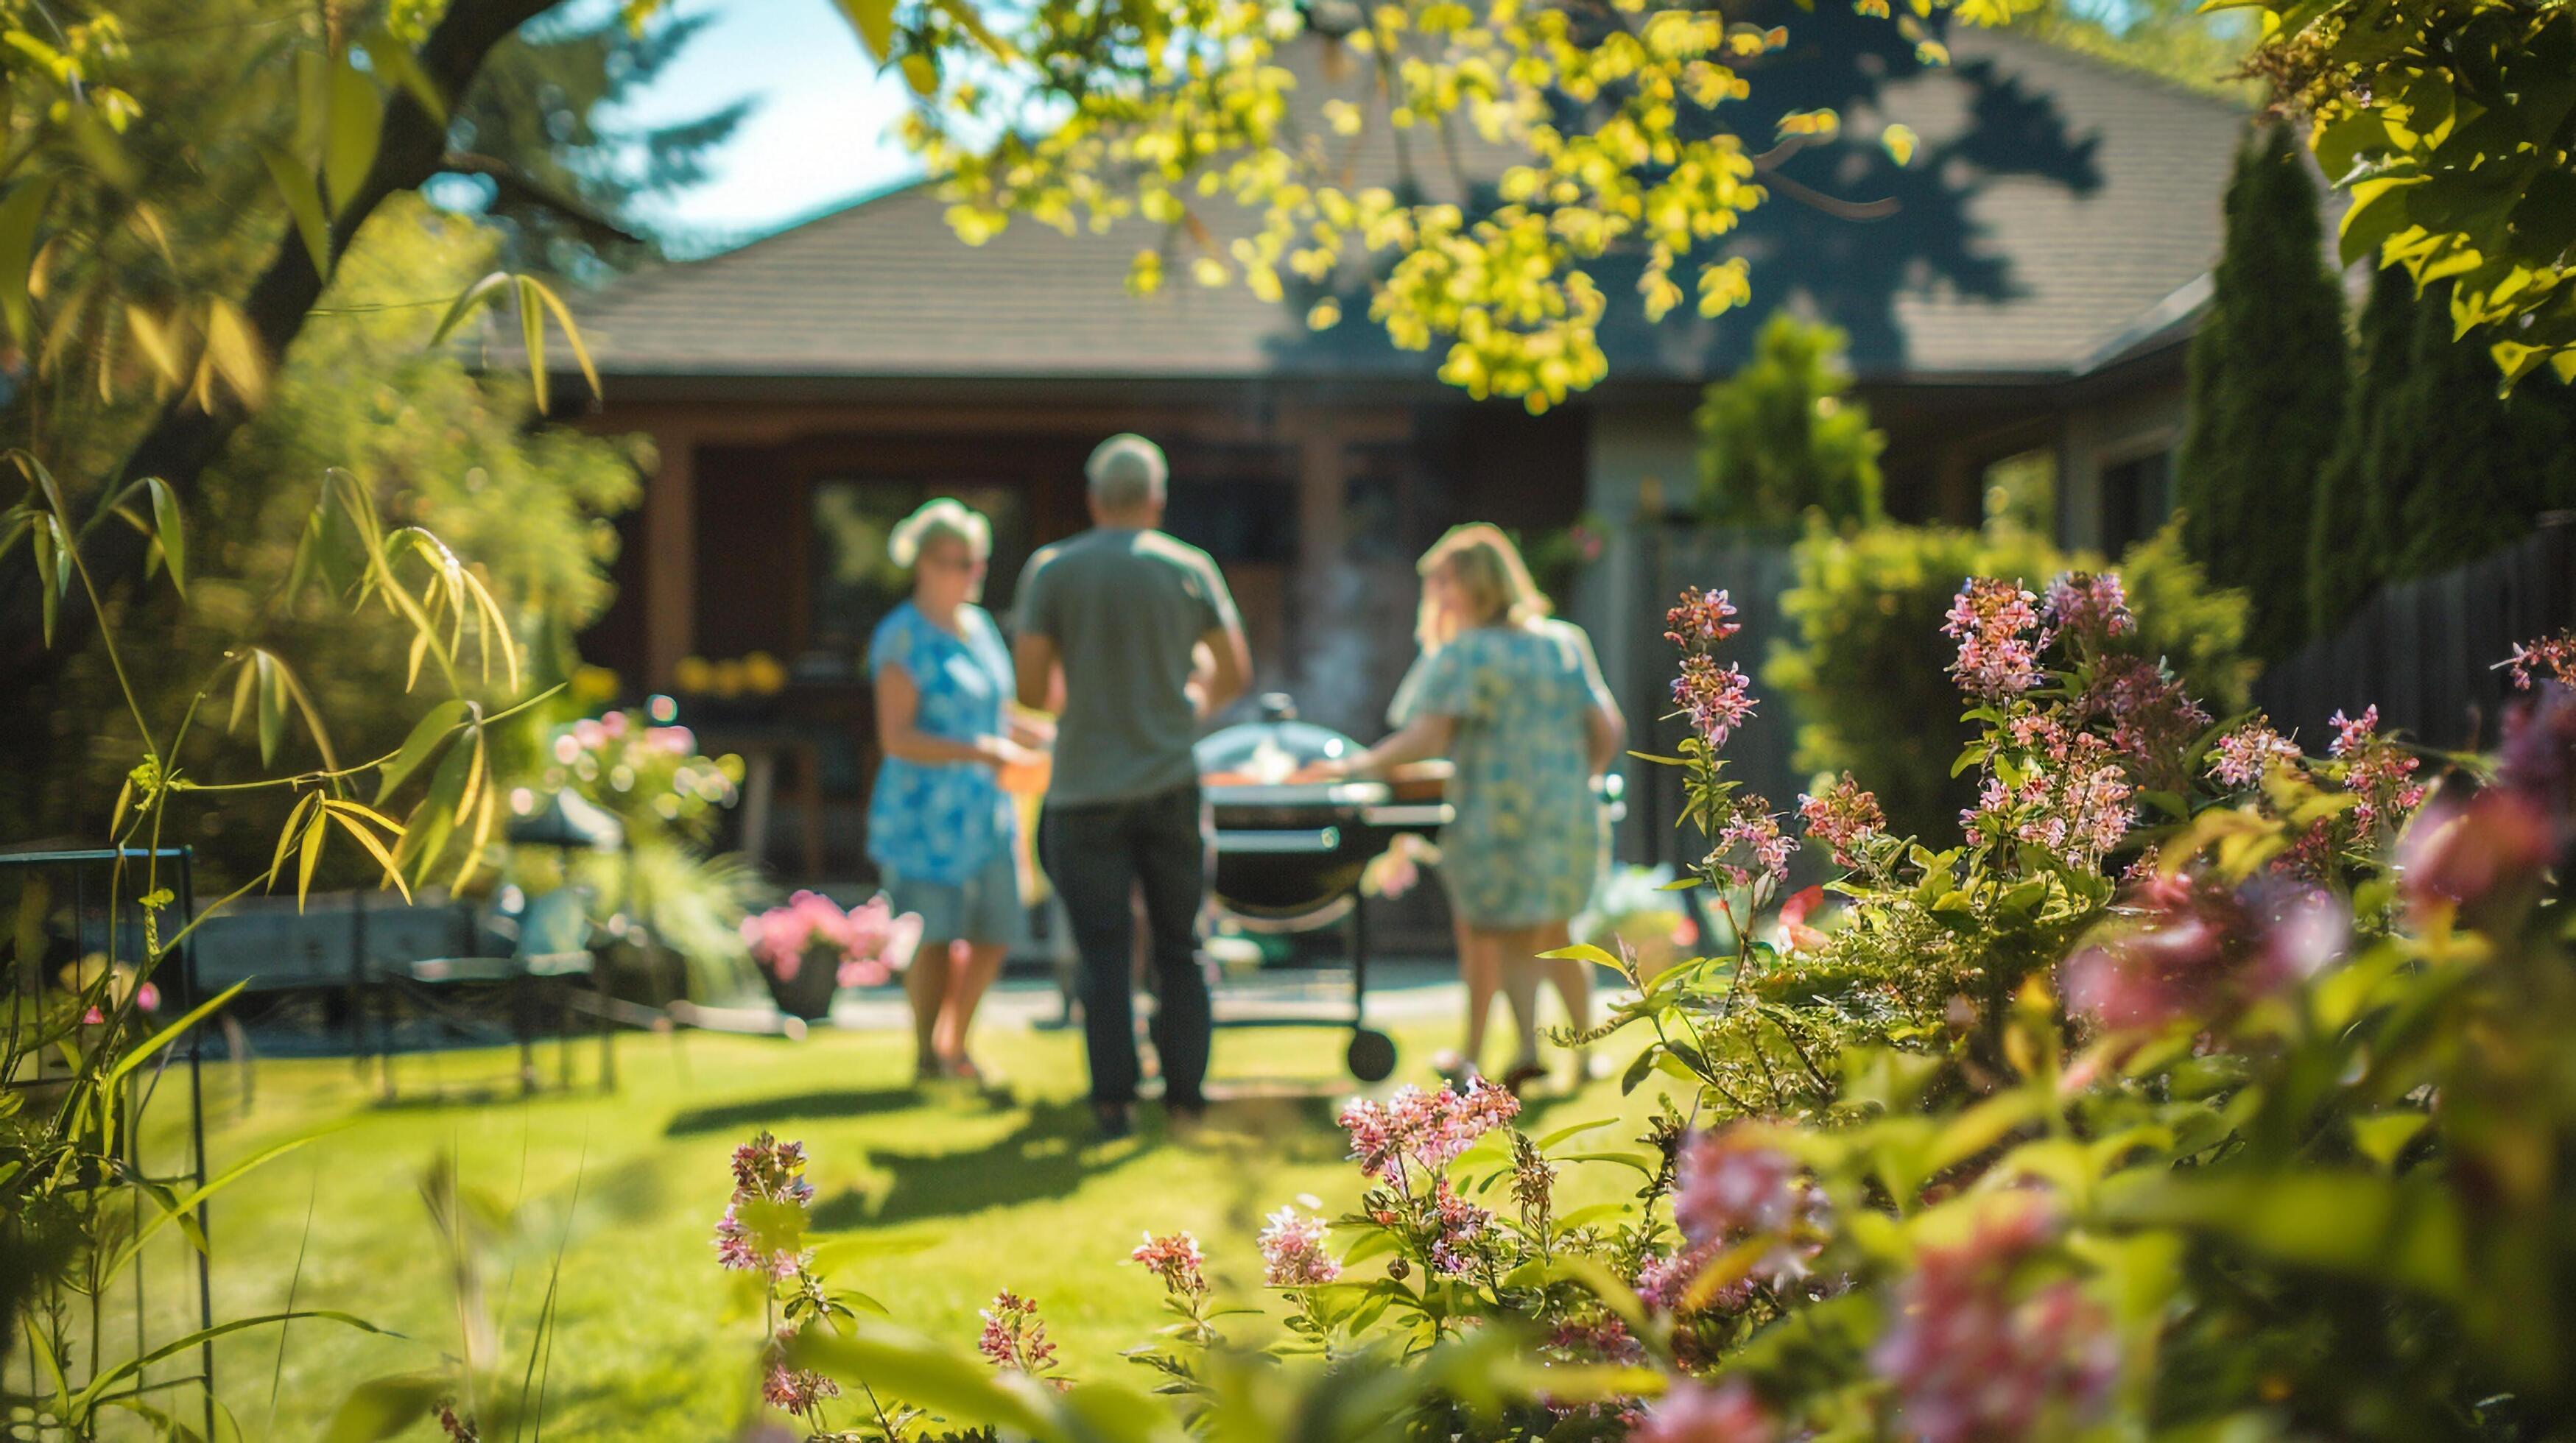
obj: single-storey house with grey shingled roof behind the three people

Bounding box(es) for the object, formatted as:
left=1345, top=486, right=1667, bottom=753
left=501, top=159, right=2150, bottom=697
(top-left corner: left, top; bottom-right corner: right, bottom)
left=528, top=8, right=2244, bottom=869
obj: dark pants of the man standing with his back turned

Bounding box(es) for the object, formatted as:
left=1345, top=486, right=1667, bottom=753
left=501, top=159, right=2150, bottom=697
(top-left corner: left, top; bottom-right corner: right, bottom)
left=1038, top=781, right=1208, bottom=1108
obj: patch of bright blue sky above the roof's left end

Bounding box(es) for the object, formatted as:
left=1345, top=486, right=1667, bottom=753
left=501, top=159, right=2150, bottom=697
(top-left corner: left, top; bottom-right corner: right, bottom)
left=602, top=0, right=915, bottom=250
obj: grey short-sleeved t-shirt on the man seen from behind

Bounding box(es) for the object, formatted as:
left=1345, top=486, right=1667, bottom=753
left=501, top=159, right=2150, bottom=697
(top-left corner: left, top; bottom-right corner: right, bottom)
left=1018, top=526, right=1236, bottom=807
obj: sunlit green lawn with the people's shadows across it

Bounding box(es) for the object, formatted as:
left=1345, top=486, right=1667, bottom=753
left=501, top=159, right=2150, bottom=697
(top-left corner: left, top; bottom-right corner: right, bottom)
left=186, top=1020, right=1646, bottom=1443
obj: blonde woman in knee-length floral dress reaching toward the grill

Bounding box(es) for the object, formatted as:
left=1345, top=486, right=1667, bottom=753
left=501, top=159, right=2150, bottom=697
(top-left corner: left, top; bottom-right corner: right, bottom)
left=1329, top=523, right=1625, bottom=1090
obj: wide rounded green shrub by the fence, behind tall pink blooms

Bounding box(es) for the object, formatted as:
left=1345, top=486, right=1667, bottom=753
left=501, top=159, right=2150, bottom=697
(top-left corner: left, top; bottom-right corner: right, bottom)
left=1762, top=526, right=2254, bottom=838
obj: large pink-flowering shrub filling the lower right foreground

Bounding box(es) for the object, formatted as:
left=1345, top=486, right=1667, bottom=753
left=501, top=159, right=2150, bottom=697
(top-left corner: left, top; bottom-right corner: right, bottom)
left=705, top=575, right=2576, bottom=1443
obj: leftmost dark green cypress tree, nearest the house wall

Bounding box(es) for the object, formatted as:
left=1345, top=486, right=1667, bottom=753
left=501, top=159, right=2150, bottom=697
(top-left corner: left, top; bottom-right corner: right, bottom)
left=2177, top=121, right=2347, bottom=657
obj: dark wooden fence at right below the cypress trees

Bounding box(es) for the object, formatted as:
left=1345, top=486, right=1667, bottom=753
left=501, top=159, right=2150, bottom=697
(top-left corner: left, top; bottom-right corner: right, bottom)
left=2254, top=513, right=2576, bottom=750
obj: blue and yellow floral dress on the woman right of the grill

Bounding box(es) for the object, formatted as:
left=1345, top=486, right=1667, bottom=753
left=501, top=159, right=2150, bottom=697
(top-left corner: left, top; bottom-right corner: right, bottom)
left=1388, top=621, right=1610, bottom=928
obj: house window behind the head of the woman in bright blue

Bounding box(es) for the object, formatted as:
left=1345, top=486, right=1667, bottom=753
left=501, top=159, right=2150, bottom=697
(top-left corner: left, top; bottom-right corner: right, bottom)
left=809, top=479, right=1028, bottom=663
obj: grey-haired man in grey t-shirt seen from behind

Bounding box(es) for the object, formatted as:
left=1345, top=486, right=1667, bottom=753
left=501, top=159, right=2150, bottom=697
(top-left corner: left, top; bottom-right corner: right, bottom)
left=1013, top=436, right=1252, bottom=1137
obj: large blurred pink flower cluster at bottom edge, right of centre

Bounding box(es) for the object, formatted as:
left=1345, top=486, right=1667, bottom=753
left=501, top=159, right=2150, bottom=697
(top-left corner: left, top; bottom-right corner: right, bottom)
left=1871, top=1199, right=2120, bottom=1443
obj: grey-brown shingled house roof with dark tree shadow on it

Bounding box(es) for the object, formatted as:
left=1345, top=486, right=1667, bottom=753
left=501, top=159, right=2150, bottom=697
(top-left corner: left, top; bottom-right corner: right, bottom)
left=538, top=24, right=2244, bottom=389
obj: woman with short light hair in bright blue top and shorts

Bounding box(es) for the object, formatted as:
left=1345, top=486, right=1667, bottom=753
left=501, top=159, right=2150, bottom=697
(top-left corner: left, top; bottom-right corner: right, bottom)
left=868, top=498, right=1041, bottom=1080
